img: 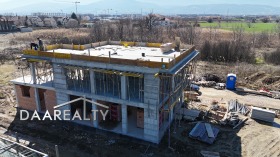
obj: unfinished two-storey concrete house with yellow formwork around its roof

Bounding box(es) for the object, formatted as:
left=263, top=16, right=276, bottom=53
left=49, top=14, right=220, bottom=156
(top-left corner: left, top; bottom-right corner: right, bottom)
left=12, top=41, right=199, bottom=143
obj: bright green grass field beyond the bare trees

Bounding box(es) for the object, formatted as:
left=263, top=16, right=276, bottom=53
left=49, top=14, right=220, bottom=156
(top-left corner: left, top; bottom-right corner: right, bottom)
left=200, top=22, right=277, bottom=32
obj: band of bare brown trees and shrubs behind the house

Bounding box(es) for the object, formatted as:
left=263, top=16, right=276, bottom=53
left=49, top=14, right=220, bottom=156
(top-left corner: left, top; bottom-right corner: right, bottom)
left=42, top=14, right=280, bottom=62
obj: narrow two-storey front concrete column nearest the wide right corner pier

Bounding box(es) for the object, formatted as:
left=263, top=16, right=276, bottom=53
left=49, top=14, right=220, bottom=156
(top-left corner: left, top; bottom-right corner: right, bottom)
left=121, top=76, right=127, bottom=134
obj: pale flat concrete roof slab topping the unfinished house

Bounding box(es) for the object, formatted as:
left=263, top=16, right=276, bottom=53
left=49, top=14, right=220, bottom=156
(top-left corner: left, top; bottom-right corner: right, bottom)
left=47, top=45, right=181, bottom=63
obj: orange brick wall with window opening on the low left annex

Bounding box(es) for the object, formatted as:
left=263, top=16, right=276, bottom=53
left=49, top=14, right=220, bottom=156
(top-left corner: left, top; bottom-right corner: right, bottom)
left=15, top=85, right=37, bottom=111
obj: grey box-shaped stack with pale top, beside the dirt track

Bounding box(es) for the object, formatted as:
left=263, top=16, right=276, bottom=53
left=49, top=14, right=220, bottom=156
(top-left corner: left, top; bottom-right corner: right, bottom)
left=251, top=107, right=275, bottom=123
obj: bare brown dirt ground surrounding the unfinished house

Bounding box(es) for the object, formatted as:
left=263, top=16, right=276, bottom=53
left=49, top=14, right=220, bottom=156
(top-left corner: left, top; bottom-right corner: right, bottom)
left=0, top=31, right=280, bottom=157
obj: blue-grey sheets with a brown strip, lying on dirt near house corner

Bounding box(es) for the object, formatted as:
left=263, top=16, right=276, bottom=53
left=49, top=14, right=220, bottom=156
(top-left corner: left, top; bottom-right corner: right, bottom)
left=189, top=122, right=219, bottom=144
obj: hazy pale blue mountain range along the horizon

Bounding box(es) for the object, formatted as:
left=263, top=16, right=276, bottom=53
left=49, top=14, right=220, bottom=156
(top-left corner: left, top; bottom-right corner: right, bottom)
left=0, top=0, right=280, bottom=15
